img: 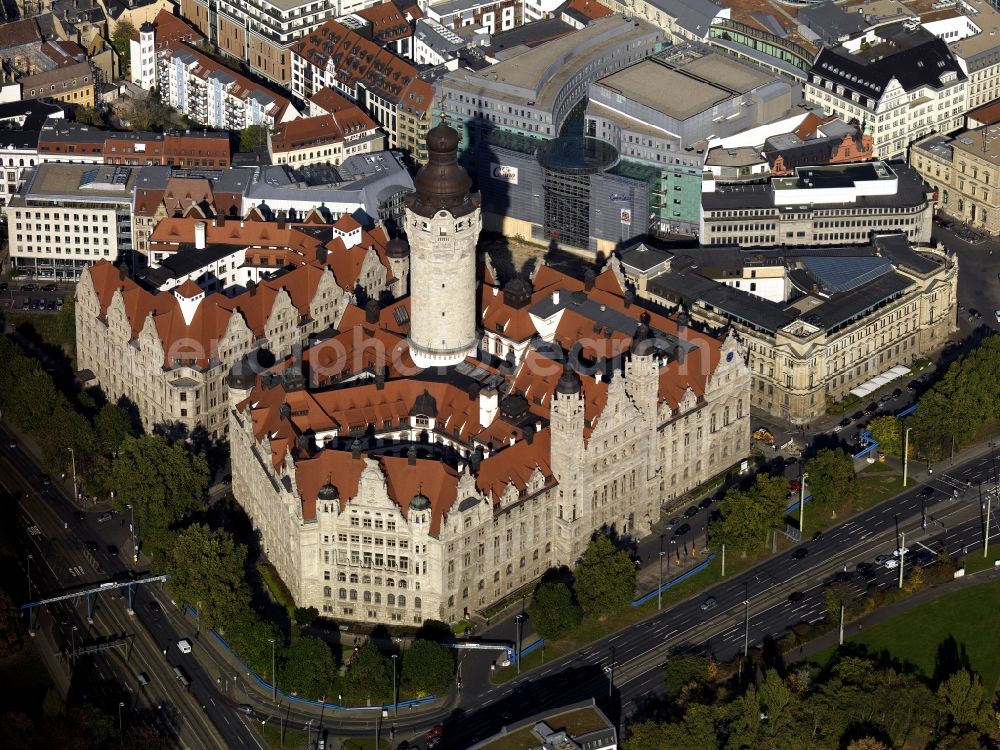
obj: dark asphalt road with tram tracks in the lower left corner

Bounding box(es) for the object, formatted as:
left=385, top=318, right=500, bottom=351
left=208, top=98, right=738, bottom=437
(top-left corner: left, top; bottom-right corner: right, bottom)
left=0, top=428, right=261, bottom=748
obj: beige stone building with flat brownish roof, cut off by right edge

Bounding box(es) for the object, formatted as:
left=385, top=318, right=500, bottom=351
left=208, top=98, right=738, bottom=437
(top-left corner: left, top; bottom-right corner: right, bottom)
left=910, top=125, right=1000, bottom=234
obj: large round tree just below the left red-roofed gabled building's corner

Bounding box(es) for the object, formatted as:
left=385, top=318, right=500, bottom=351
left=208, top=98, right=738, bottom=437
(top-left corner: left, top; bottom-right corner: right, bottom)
left=108, top=435, right=208, bottom=548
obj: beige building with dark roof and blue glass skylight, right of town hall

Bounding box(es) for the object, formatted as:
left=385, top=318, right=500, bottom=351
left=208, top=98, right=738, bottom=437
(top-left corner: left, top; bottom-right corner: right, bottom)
left=620, top=234, right=958, bottom=425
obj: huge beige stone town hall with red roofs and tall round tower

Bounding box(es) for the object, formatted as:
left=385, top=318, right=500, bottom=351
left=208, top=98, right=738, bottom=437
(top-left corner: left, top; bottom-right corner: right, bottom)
left=230, top=126, right=750, bottom=625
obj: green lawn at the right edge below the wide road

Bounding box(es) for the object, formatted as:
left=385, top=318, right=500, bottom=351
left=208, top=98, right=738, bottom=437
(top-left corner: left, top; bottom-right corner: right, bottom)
left=815, top=581, right=1000, bottom=691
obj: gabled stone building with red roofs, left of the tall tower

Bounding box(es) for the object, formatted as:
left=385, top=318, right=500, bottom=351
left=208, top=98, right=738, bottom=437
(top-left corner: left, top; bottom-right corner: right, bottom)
left=76, top=217, right=398, bottom=439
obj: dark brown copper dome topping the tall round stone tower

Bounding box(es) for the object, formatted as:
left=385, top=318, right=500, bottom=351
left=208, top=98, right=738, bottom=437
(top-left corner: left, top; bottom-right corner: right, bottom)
left=406, top=122, right=478, bottom=217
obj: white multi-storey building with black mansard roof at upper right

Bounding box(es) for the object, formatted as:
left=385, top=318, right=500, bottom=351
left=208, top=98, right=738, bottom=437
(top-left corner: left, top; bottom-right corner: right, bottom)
left=805, top=21, right=968, bottom=159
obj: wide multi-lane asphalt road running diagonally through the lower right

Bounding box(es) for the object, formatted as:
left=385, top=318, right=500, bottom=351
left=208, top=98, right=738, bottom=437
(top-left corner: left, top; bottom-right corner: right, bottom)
left=445, top=455, right=1000, bottom=748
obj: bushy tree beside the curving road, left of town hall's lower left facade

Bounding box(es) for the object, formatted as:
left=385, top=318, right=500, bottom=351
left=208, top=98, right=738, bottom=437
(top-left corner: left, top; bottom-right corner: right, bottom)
left=166, top=524, right=250, bottom=628
